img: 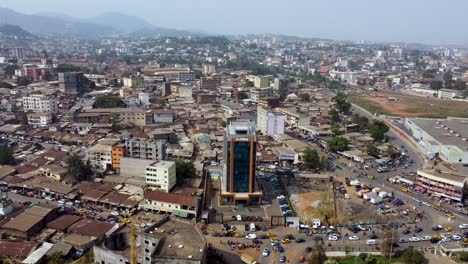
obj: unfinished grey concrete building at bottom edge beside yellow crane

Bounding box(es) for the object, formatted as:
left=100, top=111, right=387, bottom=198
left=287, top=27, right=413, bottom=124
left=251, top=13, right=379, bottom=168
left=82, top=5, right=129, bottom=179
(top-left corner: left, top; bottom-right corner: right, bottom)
left=93, top=216, right=207, bottom=264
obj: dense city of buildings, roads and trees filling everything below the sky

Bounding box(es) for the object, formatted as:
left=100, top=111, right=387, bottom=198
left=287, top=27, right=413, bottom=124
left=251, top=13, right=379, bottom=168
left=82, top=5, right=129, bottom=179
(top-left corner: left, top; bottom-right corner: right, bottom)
left=0, top=3, right=468, bottom=264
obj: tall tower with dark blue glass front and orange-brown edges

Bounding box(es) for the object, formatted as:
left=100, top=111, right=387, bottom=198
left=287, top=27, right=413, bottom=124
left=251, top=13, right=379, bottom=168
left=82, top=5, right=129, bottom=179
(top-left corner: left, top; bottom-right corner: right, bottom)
left=220, top=122, right=262, bottom=204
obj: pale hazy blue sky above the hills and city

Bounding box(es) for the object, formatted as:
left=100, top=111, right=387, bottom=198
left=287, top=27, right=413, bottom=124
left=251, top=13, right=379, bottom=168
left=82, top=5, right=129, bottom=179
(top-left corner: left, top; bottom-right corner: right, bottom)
left=0, top=0, right=468, bottom=44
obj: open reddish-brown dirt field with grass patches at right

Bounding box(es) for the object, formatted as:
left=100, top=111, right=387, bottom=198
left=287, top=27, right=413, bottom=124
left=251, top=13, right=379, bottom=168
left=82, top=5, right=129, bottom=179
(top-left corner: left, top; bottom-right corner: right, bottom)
left=348, top=92, right=468, bottom=118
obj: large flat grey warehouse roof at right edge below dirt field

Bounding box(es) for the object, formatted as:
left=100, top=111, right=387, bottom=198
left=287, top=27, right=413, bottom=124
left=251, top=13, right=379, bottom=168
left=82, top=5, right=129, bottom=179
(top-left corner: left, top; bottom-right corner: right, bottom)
left=408, top=117, right=468, bottom=148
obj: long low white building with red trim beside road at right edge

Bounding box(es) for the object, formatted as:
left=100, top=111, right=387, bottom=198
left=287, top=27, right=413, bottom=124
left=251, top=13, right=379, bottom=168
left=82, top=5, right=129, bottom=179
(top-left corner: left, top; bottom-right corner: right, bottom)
left=415, top=170, right=466, bottom=203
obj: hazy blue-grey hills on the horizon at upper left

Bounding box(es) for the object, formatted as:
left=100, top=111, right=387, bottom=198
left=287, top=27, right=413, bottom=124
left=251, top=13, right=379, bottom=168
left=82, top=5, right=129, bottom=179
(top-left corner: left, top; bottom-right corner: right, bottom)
left=0, top=8, right=204, bottom=37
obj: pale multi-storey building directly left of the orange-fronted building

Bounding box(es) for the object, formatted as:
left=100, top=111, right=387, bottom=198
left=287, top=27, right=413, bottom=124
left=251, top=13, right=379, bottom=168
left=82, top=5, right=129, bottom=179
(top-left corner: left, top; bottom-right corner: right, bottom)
left=86, top=139, right=119, bottom=170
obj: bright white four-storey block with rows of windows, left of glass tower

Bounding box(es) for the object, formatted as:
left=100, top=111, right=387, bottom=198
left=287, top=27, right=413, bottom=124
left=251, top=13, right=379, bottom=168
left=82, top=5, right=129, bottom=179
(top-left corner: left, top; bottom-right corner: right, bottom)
left=145, top=161, right=176, bottom=192
